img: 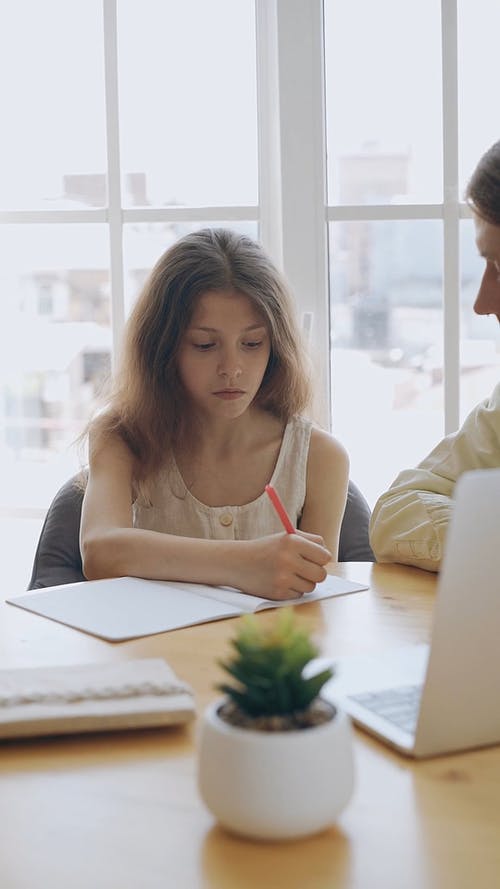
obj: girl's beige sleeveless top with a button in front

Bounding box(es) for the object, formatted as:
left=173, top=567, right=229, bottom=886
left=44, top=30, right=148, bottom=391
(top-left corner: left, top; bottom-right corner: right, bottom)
left=133, top=416, right=312, bottom=540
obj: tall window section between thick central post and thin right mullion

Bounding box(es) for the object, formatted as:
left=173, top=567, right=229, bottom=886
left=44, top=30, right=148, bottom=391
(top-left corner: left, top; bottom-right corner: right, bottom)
left=325, top=0, right=444, bottom=502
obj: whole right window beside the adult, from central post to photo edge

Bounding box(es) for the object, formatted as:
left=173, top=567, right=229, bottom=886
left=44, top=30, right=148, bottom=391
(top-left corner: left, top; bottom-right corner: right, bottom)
left=324, top=0, right=500, bottom=503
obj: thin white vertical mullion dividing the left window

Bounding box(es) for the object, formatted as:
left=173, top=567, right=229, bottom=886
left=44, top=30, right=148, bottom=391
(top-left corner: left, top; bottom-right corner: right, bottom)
left=103, top=0, right=125, bottom=363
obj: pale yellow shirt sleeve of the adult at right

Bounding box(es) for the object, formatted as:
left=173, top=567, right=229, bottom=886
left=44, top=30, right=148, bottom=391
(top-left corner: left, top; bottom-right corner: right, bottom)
left=370, top=384, right=500, bottom=571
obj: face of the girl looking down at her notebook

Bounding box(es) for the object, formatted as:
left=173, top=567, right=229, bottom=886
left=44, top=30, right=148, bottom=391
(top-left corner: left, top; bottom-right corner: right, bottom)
left=177, top=290, right=271, bottom=419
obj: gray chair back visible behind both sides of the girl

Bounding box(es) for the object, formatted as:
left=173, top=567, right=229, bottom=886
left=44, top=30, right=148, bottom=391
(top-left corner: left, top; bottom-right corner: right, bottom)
left=28, top=476, right=375, bottom=590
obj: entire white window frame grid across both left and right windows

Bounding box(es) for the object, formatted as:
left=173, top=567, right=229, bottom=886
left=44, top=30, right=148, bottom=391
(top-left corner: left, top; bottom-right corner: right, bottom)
left=0, top=0, right=471, bottom=432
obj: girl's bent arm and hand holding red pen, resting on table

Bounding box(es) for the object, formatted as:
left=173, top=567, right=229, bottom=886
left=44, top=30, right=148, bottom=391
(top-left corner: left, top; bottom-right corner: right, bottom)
left=80, top=426, right=331, bottom=599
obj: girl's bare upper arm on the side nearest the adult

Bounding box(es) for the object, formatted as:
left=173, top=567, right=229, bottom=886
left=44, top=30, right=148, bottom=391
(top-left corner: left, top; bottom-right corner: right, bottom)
left=300, top=428, right=349, bottom=561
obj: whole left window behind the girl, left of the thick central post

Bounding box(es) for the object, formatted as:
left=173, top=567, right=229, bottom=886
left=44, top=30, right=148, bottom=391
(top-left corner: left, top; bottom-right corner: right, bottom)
left=0, top=0, right=258, bottom=587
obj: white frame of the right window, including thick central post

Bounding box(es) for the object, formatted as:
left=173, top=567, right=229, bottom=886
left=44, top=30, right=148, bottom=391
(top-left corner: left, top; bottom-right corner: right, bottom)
left=257, top=0, right=471, bottom=433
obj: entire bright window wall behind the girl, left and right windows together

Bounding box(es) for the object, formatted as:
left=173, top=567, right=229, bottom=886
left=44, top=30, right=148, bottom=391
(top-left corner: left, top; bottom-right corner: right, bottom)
left=0, top=0, right=500, bottom=585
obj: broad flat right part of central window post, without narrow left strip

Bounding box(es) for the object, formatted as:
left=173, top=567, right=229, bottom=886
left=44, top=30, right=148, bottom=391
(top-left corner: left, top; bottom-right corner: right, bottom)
left=277, top=0, right=330, bottom=426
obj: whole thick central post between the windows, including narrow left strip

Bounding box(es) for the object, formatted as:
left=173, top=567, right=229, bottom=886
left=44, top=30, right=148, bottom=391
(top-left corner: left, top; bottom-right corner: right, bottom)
left=256, top=0, right=331, bottom=427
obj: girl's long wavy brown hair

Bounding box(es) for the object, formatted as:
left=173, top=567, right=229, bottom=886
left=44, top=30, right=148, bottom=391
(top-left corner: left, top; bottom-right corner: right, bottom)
left=91, top=229, right=310, bottom=483
